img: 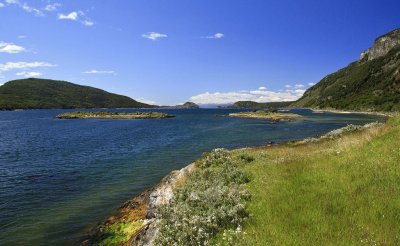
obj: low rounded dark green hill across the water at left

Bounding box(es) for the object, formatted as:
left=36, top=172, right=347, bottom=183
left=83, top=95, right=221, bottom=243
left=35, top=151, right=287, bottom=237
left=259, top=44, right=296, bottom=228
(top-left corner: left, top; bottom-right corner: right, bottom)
left=0, top=78, right=154, bottom=109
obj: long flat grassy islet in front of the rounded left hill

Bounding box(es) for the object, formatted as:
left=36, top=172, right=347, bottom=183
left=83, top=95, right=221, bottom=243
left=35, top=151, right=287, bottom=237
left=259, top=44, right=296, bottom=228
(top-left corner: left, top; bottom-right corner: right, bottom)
left=55, top=112, right=175, bottom=120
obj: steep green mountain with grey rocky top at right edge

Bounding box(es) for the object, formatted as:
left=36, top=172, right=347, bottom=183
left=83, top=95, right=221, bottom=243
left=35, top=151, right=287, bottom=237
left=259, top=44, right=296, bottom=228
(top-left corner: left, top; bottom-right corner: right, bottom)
left=291, top=29, right=400, bottom=111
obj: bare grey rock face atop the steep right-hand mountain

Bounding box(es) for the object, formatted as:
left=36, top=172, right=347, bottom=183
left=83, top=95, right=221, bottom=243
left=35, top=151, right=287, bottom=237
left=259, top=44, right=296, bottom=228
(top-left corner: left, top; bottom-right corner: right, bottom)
left=360, top=29, right=400, bottom=61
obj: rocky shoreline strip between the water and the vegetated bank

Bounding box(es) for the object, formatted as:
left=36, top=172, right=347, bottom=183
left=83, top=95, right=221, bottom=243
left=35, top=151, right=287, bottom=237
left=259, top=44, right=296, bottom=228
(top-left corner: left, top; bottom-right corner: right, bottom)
left=81, top=109, right=393, bottom=245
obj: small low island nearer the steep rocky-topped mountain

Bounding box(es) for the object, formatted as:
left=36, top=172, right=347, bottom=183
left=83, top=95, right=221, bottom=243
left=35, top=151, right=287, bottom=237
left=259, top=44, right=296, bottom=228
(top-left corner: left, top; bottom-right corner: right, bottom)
left=228, top=110, right=302, bottom=122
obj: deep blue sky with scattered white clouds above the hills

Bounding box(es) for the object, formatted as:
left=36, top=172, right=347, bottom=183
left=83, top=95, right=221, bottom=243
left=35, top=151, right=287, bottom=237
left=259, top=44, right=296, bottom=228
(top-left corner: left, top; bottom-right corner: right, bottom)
left=0, top=0, right=400, bottom=105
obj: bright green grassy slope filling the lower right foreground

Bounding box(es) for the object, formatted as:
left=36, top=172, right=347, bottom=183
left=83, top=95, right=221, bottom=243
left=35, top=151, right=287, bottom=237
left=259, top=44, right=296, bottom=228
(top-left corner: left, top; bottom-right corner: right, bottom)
left=231, top=117, right=400, bottom=245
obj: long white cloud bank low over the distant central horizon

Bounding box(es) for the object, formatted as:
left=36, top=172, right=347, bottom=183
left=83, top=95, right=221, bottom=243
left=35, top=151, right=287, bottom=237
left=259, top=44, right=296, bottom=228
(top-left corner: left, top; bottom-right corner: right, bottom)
left=189, top=89, right=305, bottom=105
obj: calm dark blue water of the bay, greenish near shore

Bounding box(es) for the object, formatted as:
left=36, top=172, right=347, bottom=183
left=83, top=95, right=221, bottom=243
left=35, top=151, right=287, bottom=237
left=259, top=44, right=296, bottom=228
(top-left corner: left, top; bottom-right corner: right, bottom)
left=0, top=109, right=383, bottom=245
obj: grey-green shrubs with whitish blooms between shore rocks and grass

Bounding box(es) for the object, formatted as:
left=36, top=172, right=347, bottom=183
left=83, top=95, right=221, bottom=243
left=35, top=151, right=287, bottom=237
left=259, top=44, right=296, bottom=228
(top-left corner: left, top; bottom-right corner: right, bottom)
left=155, top=149, right=251, bottom=245
